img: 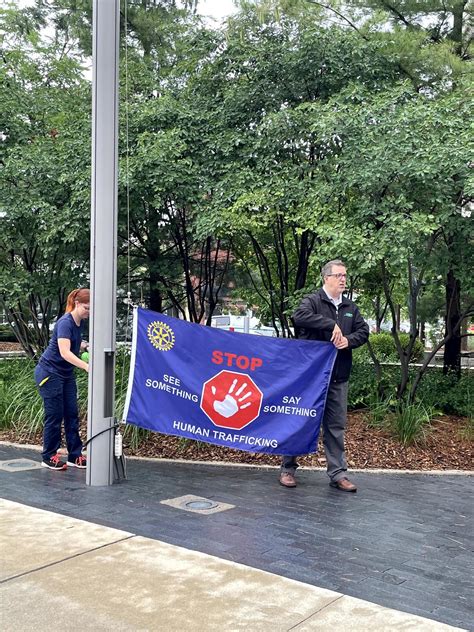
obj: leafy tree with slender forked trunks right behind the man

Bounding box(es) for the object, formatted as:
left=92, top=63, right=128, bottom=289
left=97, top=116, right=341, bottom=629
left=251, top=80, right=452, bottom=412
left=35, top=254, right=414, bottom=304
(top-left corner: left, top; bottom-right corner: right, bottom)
left=296, top=84, right=474, bottom=400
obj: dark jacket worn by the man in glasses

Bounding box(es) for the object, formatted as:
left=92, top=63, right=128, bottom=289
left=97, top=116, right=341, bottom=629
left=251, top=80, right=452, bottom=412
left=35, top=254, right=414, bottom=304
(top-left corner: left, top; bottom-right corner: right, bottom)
left=292, top=288, right=369, bottom=382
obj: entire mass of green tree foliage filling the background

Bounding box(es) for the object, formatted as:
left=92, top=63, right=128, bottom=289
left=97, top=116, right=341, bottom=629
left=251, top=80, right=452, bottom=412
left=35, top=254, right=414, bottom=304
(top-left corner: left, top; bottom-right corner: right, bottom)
left=0, top=0, right=474, bottom=390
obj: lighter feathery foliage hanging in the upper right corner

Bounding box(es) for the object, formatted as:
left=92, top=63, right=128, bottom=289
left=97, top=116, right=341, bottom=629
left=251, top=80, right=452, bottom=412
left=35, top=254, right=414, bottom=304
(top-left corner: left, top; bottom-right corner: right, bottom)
left=257, top=0, right=473, bottom=87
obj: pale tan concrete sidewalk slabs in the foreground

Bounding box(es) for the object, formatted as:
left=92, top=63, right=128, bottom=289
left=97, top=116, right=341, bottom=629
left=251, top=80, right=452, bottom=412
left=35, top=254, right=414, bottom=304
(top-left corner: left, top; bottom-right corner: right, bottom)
left=0, top=500, right=460, bottom=632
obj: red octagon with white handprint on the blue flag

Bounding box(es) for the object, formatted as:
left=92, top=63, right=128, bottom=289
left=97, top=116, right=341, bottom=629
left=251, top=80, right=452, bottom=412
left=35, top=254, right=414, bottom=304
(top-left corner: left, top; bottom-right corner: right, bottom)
left=201, top=371, right=263, bottom=430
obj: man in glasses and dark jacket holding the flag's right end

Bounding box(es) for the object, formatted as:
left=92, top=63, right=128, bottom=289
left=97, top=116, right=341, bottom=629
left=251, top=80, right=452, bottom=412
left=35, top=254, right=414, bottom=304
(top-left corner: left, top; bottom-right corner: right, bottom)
left=280, top=259, right=369, bottom=492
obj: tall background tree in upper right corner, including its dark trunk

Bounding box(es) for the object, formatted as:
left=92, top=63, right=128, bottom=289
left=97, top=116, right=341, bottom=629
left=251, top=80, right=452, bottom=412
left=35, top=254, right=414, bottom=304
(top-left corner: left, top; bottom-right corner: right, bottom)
left=256, top=0, right=474, bottom=375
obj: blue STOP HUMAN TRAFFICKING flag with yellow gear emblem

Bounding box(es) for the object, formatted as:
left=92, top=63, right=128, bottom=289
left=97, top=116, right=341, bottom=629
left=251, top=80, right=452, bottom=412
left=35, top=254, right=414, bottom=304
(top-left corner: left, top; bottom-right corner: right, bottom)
left=124, top=308, right=337, bottom=455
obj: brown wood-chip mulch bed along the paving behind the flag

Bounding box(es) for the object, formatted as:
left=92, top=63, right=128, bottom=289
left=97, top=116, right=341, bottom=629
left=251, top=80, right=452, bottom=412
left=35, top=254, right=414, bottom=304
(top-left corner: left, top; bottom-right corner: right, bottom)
left=0, top=411, right=474, bottom=470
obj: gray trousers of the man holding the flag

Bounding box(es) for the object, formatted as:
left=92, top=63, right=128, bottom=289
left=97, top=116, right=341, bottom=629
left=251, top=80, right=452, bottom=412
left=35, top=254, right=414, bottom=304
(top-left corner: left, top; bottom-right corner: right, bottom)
left=281, top=382, right=349, bottom=482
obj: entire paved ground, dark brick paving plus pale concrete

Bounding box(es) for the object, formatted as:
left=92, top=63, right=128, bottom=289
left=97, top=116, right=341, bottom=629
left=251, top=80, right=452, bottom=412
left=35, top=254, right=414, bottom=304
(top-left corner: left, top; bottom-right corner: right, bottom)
left=0, top=445, right=473, bottom=632
